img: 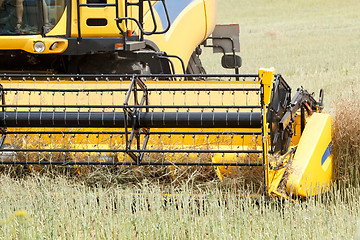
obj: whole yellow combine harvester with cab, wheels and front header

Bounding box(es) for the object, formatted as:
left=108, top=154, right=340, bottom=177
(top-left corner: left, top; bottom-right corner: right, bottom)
left=0, top=0, right=333, bottom=199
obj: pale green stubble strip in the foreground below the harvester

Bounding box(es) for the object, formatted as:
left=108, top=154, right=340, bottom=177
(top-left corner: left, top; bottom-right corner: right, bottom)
left=0, top=175, right=360, bottom=239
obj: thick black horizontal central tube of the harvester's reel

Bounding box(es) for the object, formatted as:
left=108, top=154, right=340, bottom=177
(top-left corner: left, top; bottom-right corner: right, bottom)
left=0, top=112, right=261, bottom=128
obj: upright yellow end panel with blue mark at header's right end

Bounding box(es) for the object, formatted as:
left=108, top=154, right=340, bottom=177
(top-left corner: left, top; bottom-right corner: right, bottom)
left=287, top=113, right=333, bottom=197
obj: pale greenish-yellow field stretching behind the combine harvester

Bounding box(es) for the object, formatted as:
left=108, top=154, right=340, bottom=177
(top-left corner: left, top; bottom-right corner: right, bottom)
left=204, top=0, right=360, bottom=110
